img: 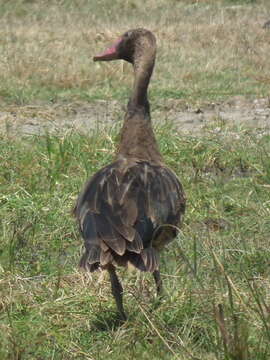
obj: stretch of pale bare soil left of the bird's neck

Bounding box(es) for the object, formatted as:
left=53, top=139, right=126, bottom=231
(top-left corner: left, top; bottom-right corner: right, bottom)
left=0, top=101, right=120, bottom=136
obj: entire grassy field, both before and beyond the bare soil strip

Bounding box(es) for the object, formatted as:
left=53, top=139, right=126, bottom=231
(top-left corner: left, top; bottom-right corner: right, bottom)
left=0, top=0, right=270, bottom=360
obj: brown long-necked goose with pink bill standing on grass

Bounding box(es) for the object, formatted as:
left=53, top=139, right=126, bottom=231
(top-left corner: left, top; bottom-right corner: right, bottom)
left=74, top=28, right=186, bottom=321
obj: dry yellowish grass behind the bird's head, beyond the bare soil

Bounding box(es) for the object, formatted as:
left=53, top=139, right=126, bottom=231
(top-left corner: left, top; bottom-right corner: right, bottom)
left=0, top=0, right=270, bottom=105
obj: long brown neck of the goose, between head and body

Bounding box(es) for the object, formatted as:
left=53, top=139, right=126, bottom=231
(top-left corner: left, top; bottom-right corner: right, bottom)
left=117, top=52, right=162, bottom=163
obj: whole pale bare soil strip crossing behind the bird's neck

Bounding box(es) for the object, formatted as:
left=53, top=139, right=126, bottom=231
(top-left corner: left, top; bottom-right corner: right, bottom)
left=0, top=96, right=270, bottom=136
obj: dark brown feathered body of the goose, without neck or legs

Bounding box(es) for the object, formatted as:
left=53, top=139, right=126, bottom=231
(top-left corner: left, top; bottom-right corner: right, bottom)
left=74, top=160, right=185, bottom=271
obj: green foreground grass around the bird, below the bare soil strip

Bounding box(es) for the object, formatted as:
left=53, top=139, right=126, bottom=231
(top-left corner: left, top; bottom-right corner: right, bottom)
left=0, top=125, right=270, bottom=360
